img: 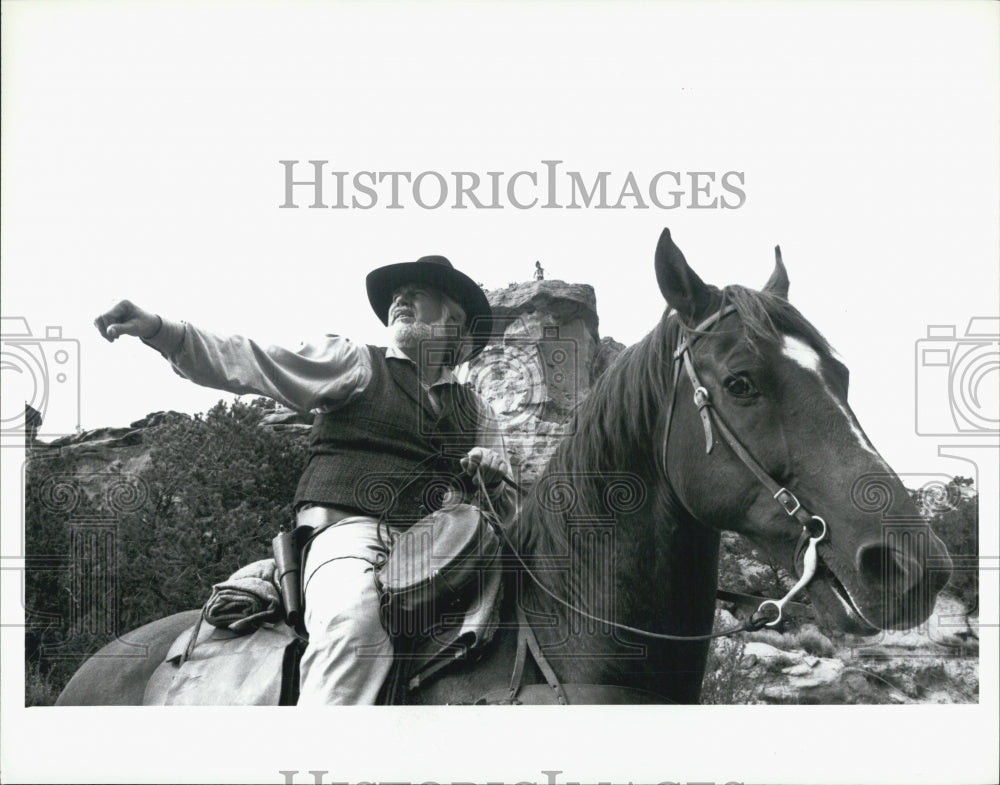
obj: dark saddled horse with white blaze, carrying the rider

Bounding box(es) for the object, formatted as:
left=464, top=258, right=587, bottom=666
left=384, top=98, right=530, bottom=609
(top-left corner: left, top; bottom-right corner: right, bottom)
left=57, top=229, right=951, bottom=705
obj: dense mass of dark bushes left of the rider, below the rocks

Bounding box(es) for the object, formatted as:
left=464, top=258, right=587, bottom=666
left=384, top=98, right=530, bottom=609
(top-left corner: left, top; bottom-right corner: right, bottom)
left=25, top=399, right=306, bottom=702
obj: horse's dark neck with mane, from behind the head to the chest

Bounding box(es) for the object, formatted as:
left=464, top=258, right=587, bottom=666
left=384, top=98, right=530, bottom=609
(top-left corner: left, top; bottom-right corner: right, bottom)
left=522, top=318, right=719, bottom=700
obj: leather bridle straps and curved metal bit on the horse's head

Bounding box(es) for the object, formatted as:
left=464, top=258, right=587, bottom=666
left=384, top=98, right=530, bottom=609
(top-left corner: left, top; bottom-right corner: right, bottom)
left=663, top=305, right=826, bottom=627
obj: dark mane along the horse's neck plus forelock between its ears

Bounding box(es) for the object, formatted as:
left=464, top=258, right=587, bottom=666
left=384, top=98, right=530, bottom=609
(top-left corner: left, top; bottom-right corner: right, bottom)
left=512, top=285, right=832, bottom=593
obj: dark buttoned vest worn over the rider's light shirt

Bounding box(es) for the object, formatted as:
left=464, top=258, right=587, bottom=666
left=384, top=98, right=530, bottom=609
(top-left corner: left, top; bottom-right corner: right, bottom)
left=295, top=346, right=480, bottom=526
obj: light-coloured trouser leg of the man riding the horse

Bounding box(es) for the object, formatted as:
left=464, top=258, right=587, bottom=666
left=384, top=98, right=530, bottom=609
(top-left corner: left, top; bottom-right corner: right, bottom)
left=298, top=516, right=393, bottom=706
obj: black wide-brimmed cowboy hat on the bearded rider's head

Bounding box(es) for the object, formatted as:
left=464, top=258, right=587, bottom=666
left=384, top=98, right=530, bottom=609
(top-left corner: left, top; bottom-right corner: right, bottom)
left=365, top=256, right=493, bottom=357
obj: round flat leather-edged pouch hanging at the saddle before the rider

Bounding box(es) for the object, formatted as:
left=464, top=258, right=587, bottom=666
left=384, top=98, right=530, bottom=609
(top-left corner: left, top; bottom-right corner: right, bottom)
left=375, top=504, right=501, bottom=631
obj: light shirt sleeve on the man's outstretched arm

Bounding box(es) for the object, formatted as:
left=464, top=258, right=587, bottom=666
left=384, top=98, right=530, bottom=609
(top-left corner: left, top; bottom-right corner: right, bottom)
left=145, top=320, right=372, bottom=412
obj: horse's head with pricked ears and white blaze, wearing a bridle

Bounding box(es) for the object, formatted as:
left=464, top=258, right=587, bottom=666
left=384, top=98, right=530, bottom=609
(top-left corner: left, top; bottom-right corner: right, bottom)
left=656, top=230, right=950, bottom=634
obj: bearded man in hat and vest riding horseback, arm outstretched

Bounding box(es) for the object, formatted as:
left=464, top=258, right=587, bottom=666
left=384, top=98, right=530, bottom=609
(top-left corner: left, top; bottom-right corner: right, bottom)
left=94, top=256, right=514, bottom=705
